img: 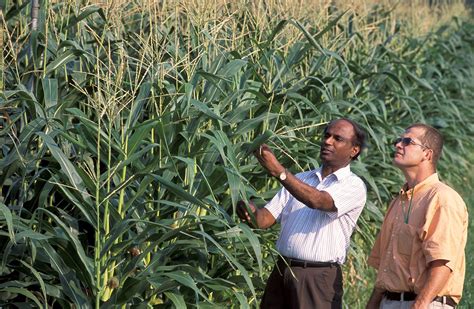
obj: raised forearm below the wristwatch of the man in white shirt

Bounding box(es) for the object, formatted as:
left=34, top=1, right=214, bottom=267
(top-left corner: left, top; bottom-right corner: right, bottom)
left=281, top=172, right=337, bottom=211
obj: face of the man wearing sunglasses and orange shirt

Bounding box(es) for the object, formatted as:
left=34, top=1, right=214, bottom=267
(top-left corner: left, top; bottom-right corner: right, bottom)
left=393, top=127, right=427, bottom=169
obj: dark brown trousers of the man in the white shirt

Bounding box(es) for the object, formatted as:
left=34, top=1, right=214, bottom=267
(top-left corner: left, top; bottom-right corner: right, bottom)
left=260, top=259, right=343, bottom=309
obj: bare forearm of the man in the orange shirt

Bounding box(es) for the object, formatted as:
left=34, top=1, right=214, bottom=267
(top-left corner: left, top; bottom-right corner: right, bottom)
left=412, top=260, right=451, bottom=309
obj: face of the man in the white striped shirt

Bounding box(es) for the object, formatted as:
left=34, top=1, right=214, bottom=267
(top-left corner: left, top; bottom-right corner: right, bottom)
left=319, top=120, right=360, bottom=167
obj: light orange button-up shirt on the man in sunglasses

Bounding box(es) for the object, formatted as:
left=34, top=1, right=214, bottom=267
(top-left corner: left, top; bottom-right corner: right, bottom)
left=368, top=174, right=468, bottom=303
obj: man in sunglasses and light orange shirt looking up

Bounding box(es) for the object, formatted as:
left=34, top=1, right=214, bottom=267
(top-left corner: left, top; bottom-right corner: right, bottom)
left=367, top=124, right=468, bottom=309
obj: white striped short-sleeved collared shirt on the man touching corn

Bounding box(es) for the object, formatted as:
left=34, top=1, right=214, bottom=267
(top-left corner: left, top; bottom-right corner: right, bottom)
left=265, top=165, right=367, bottom=264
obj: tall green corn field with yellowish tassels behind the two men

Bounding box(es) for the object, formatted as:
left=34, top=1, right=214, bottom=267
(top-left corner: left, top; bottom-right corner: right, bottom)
left=0, top=0, right=474, bottom=308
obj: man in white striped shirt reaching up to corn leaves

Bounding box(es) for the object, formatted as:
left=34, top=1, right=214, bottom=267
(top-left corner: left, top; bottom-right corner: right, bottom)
left=237, top=118, right=366, bottom=309
